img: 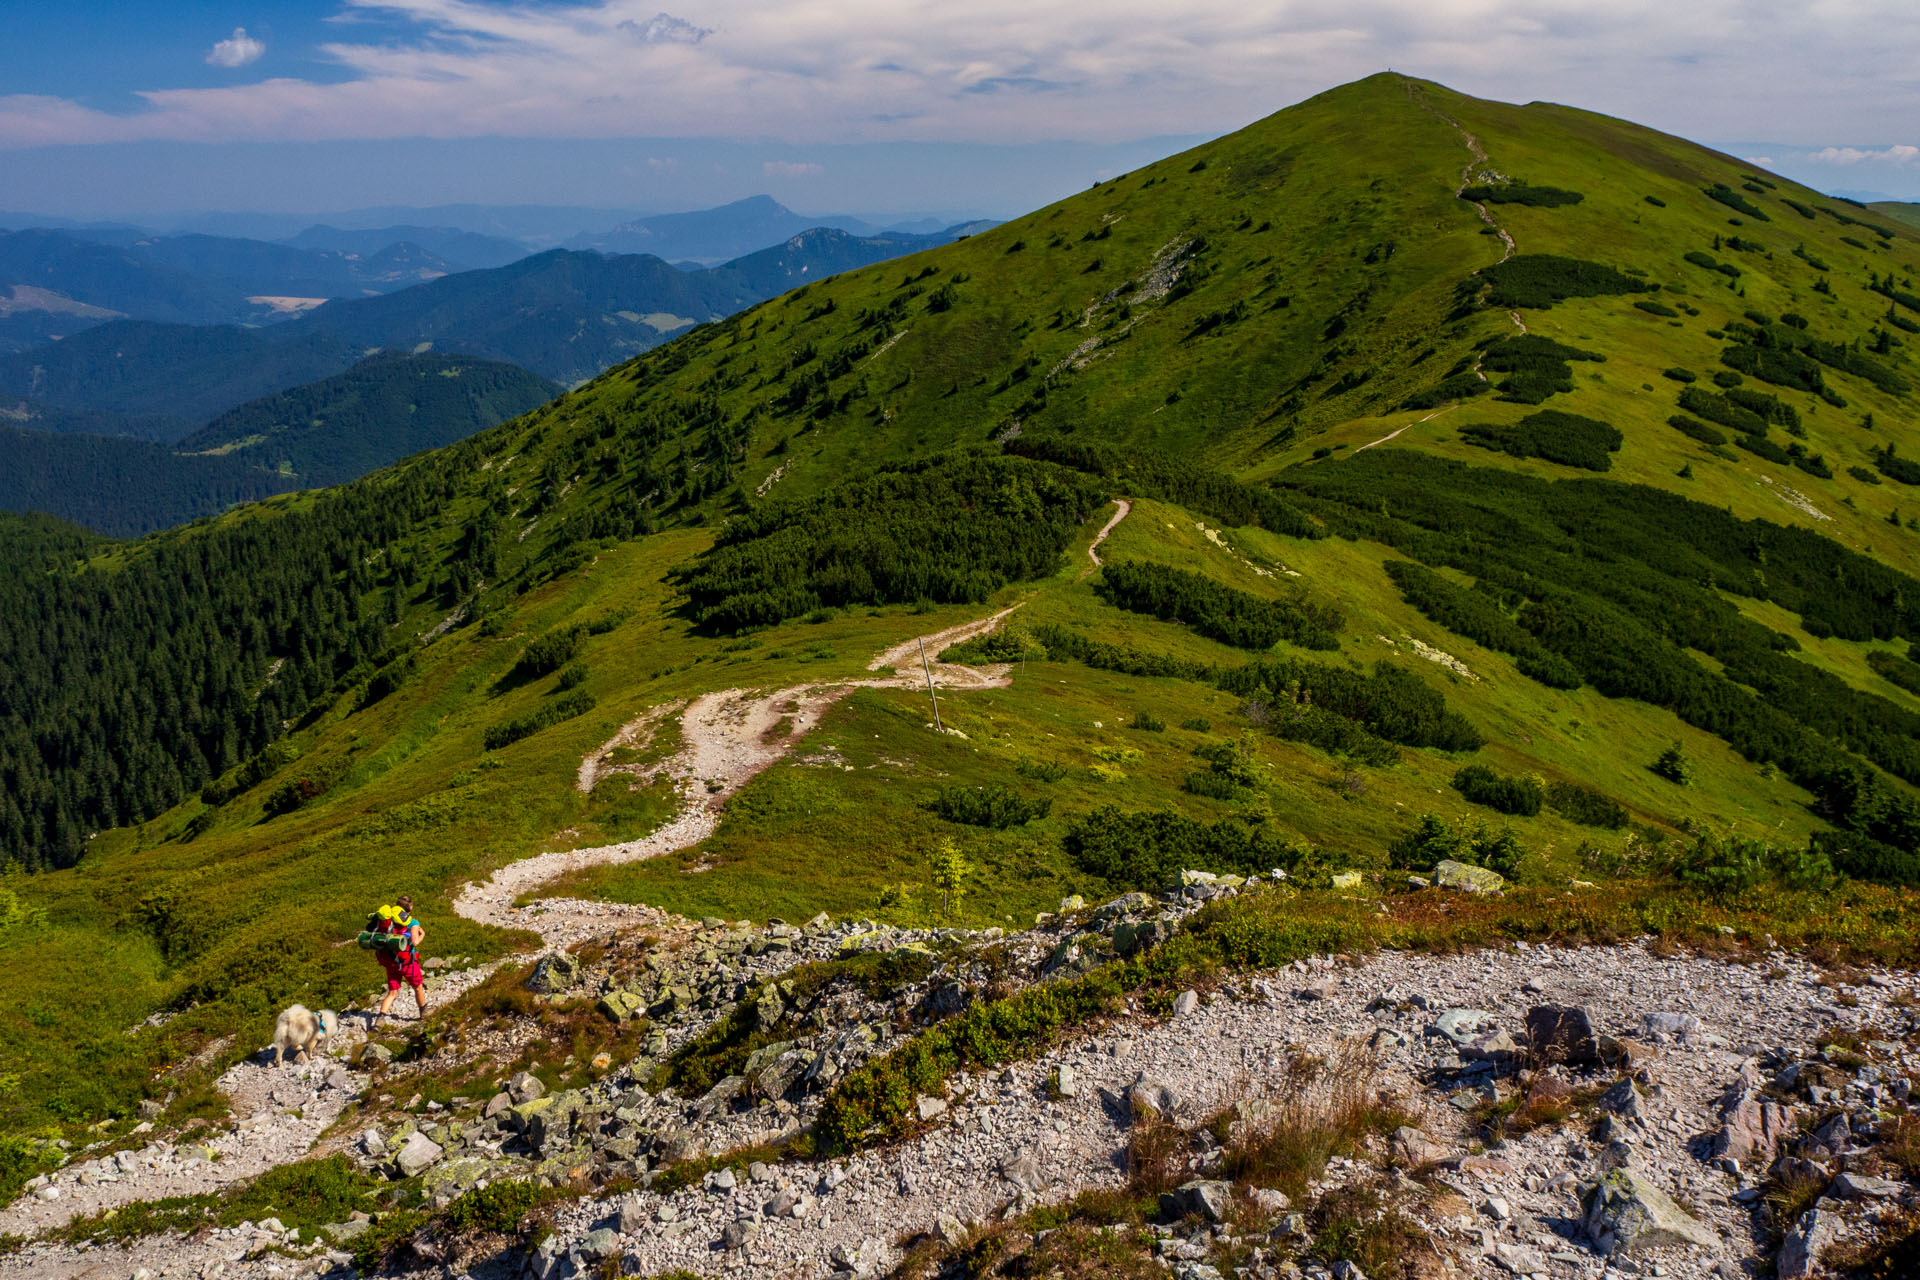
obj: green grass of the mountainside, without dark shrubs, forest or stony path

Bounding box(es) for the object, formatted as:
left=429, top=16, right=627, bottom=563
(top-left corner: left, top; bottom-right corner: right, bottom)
left=0, top=75, right=1920, bottom=1123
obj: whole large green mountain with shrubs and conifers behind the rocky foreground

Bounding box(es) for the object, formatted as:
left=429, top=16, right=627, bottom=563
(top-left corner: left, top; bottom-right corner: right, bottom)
left=0, top=75, right=1920, bottom=1143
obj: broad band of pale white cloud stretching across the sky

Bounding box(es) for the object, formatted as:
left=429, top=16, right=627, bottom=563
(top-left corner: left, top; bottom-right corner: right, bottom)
left=0, top=0, right=1920, bottom=150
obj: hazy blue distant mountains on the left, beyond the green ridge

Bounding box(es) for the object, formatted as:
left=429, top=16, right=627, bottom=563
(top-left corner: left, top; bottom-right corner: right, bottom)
left=0, top=200, right=979, bottom=535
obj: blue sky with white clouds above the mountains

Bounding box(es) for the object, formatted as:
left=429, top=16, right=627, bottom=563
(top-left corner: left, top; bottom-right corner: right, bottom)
left=0, top=0, right=1920, bottom=226
